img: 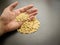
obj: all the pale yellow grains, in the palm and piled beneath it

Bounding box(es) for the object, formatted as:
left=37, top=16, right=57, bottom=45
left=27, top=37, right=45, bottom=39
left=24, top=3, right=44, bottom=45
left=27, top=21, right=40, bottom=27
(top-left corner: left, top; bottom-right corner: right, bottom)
left=16, top=13, right=40, bottom=34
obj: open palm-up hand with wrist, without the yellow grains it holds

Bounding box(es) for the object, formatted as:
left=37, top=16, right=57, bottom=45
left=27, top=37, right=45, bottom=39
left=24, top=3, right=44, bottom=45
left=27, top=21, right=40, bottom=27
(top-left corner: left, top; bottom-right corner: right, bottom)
left=0, top=1, right=37, bottom=34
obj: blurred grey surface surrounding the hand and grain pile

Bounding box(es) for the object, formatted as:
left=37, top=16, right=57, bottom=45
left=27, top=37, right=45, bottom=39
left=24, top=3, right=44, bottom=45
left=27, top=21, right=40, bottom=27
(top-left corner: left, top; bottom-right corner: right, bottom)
left=0, top=0, right=60, bottom=45
